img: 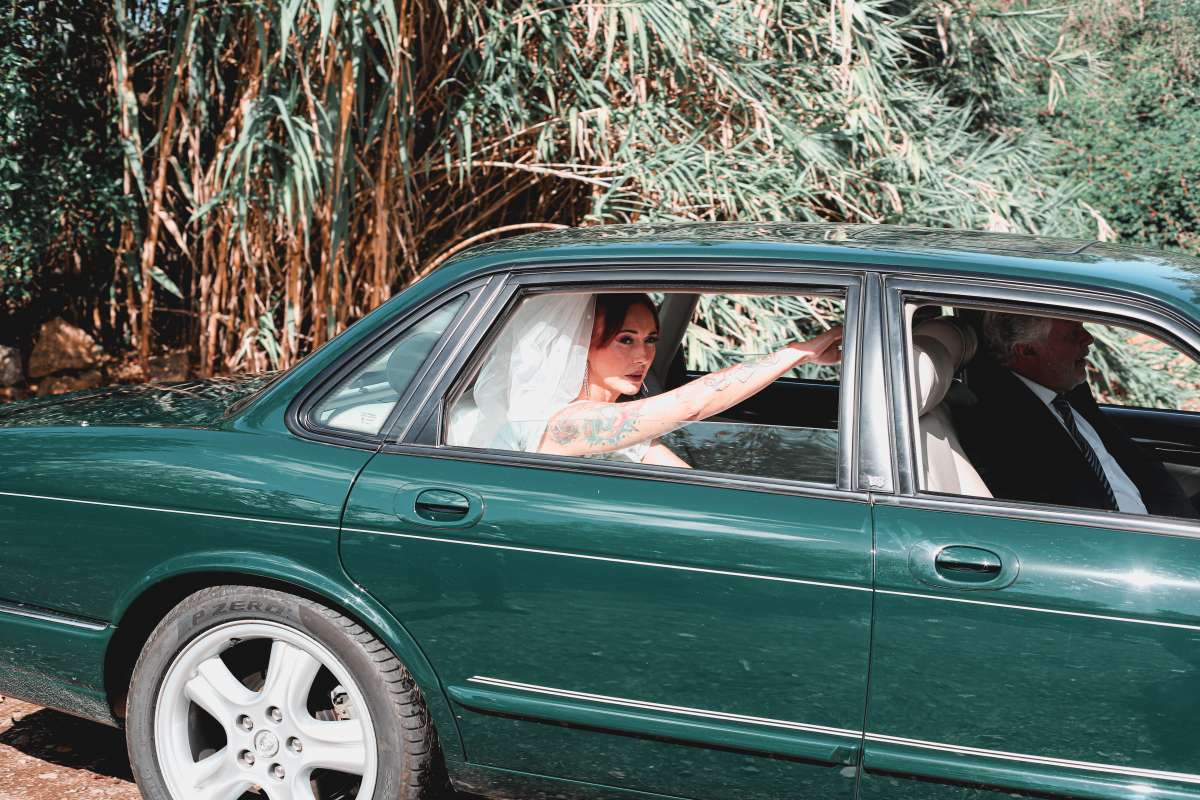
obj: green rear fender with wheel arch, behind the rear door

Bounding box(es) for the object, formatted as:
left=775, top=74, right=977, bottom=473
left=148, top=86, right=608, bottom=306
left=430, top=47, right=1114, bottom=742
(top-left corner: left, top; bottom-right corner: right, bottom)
left=0, top=427, right=468, bottom=751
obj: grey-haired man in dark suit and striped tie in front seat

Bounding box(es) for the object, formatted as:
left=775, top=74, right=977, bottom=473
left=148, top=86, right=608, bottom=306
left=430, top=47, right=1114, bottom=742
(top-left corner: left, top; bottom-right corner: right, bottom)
left=955, top=312, right=1198, bottom=517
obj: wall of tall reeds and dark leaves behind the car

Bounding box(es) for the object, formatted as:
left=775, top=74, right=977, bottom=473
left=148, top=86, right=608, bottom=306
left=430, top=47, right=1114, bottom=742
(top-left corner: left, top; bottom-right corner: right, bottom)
left=0, top=0, right=1113, bottom=372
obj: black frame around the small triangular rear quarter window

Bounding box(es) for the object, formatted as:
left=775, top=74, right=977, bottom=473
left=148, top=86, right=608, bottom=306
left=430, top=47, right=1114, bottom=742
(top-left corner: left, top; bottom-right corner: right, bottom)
left=284, top=279, right=501, bottom=450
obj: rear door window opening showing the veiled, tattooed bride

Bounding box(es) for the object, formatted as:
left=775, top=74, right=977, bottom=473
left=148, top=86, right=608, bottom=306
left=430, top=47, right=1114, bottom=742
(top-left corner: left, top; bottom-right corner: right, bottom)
left=443, top=291, right=845, bottom=485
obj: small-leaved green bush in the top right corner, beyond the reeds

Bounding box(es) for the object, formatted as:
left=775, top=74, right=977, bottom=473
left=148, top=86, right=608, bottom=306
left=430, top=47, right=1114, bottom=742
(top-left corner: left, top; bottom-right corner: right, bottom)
left=1046, top=0, right=1200, bottom=253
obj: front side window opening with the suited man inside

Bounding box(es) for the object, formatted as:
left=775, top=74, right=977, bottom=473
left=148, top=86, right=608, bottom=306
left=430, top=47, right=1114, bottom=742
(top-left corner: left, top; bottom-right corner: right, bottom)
left=907, top=299, right=1200, bottom=518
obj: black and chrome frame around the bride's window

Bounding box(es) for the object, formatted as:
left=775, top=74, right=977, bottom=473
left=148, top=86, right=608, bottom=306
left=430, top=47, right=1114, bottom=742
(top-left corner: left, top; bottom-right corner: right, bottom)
left=383, top=263, right=868, bottom=500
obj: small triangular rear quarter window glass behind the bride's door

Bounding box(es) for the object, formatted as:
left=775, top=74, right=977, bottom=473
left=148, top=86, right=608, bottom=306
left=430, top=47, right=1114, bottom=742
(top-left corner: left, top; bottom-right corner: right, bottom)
left=311, top=295, right=467, bottom=435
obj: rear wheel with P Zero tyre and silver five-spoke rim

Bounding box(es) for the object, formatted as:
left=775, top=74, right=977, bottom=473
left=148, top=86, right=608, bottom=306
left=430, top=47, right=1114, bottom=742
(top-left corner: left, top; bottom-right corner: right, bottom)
left=126, top=585, right=445, bottom=800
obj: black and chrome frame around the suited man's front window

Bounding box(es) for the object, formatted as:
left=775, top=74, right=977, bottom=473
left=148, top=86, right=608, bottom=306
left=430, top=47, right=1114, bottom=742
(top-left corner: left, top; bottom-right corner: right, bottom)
left=881, top=273, right=1200, bottom=537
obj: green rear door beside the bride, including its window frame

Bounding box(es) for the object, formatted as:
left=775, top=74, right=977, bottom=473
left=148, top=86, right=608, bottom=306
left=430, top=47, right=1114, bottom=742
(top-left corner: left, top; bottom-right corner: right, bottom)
left=342, top=267, right=871, bottom=799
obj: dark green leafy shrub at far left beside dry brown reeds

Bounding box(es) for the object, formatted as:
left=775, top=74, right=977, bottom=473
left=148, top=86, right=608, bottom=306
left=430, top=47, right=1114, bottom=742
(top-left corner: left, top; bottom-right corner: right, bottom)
left=0, top=6, right=126, bottom=321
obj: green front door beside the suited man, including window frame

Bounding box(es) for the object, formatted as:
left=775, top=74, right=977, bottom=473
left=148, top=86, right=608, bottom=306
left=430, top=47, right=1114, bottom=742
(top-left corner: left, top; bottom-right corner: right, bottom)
left=862, top=279, right=1200, bottom=800
